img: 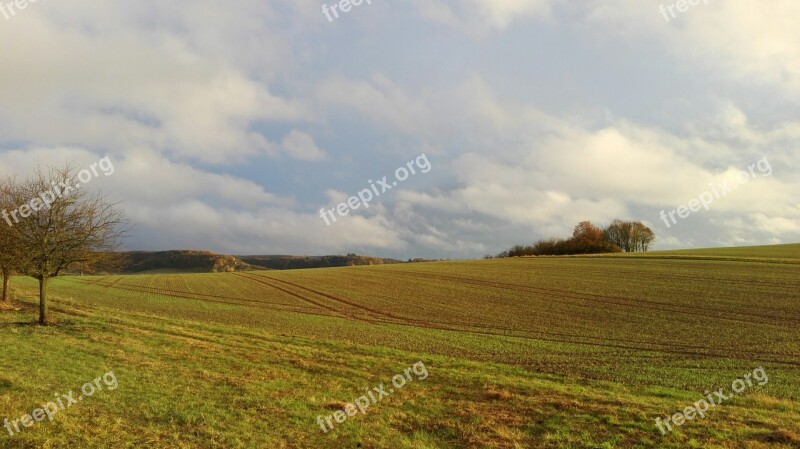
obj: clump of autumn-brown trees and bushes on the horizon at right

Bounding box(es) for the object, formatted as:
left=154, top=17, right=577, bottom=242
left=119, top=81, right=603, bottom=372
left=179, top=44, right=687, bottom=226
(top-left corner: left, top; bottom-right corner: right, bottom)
left=497, top=220, right=656, bottom=257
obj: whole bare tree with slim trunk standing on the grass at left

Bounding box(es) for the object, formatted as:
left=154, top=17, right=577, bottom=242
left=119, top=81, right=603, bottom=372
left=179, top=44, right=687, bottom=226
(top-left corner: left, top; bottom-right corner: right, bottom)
left=12, top=164, right=128, bottom=324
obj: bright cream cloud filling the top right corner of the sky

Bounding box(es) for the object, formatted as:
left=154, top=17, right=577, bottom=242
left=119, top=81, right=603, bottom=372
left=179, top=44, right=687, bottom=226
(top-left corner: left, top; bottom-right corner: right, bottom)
left=585, top=0, right=800, bottom=93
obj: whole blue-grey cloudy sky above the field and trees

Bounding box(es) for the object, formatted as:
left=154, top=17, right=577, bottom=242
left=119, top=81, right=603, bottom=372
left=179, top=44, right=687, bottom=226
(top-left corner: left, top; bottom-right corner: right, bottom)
left=0, top=0, right=800, bottom=259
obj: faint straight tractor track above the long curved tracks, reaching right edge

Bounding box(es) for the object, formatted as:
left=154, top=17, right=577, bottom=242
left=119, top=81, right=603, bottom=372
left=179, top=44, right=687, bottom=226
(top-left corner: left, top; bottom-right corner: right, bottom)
left=384, top=271, right=800, bottom=325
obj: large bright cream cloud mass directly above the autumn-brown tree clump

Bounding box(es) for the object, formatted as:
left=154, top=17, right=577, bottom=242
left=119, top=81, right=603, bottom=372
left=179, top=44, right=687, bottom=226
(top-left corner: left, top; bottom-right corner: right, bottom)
left=370, top=80, right=800, bottom=250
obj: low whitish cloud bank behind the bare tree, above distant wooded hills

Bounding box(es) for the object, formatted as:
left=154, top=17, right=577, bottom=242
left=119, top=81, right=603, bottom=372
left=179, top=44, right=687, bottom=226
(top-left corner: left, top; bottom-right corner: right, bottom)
left=0, top=144, right=408, bottom=254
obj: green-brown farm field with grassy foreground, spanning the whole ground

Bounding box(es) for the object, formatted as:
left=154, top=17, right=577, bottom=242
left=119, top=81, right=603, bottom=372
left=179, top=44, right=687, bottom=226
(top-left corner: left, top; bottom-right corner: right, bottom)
left=0, top=245, right=800, bottom=448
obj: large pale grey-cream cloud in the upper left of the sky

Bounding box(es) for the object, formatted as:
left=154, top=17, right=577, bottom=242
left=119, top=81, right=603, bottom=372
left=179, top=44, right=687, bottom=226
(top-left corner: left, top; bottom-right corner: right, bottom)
left=0, top=0, right=310, bottom=164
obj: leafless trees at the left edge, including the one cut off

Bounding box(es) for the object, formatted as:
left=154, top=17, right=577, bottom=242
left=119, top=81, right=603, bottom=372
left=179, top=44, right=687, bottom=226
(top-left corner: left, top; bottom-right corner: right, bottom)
left=0, top=164, right=128, bottom=324
